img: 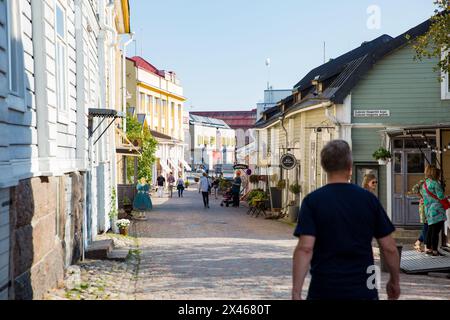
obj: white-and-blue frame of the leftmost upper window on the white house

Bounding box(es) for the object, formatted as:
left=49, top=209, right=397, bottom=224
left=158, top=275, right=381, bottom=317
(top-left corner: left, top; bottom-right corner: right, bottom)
left=6, top=0, right=26, bottom=112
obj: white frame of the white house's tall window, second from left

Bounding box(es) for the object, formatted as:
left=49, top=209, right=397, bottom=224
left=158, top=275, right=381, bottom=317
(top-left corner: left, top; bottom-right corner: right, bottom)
left=54, top=0, right=69, bottom=124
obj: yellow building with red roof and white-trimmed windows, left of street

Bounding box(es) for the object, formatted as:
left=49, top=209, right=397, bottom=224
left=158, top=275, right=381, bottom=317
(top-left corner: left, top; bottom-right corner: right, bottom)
left=126, top=57, right=186, bottom=182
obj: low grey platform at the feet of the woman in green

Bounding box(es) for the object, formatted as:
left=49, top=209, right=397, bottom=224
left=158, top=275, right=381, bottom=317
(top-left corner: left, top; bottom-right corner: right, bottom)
left=400, top=251, right=450, bottom=273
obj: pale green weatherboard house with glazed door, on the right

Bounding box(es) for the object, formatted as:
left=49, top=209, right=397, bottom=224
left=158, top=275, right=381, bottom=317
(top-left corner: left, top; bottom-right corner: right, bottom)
left=347, top=21, right=450, bottom=227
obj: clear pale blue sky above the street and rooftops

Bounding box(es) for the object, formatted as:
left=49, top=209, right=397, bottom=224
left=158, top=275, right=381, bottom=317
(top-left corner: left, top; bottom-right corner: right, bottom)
left=129, top=0, right=434, bottom=111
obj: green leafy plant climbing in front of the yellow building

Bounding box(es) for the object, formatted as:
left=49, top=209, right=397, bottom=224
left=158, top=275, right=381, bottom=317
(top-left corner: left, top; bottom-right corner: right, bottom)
left=127, top=115, right=158, bottom=183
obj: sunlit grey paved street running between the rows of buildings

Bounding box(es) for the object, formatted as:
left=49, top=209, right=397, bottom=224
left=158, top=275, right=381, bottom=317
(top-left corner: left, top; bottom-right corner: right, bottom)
left=131, top=191, right=450, bottom=300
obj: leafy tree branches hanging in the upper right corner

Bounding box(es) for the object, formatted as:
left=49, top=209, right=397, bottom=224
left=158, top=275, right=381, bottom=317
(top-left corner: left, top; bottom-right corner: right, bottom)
left=408, top=0, right=450, bottom=73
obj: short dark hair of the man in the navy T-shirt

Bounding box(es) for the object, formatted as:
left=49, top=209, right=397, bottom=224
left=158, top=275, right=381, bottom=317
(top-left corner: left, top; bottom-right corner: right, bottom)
left=321, top=140, right=353, bottom=173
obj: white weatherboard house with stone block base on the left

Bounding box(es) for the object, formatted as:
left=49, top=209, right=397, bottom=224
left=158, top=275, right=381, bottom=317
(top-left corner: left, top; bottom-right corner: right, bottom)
left=0, top=0, right=128, bottom=299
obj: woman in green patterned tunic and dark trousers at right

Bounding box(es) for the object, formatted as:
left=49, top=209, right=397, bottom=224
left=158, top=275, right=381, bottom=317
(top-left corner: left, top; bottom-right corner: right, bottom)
left=420, top=165, right=447, bottom=256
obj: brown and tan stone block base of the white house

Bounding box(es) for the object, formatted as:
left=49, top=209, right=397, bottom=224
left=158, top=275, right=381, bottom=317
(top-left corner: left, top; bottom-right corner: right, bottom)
left=10, top=173, right=84, bottom=300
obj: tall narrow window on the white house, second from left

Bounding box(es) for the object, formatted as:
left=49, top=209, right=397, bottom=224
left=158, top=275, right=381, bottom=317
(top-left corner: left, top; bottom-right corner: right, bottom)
left=55, top=2, right=68, bottom=111
